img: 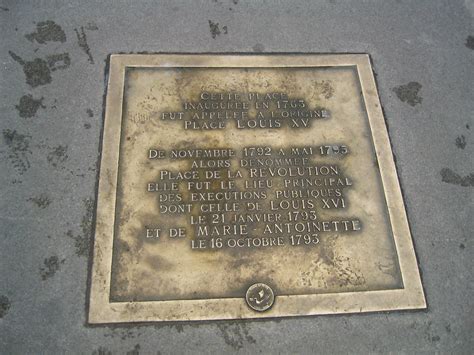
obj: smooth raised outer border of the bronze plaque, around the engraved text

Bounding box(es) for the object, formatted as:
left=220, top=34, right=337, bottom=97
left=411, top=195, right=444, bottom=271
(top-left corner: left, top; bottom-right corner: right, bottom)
left=89, top=54, right=426, bottom=323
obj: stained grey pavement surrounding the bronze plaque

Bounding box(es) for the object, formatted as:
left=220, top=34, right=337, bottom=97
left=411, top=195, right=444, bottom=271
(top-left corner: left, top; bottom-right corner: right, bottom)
left=0, top=0, right=474, bottom=354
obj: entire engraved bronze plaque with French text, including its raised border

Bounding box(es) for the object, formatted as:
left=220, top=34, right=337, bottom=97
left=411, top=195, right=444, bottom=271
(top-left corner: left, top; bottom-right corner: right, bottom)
left=89, top=54, right=426, bottom=323
